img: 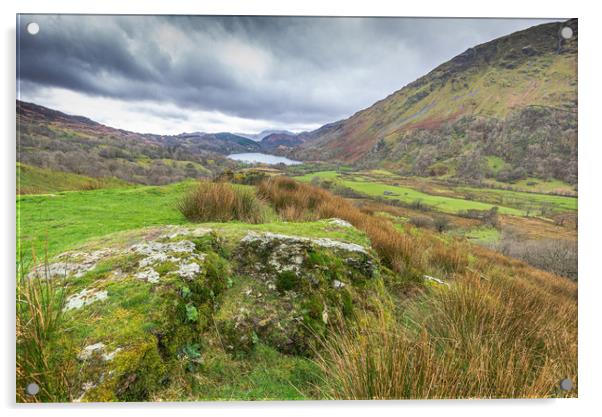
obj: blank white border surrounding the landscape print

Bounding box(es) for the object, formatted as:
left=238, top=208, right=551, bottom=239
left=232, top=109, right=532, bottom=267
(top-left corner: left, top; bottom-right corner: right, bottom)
left=0, top=0, right=602, bottom=417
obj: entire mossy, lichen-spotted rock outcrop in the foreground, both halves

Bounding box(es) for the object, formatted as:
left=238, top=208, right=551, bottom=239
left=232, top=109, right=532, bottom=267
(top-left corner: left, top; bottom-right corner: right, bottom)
left=30, top=223, right=382, bottom=401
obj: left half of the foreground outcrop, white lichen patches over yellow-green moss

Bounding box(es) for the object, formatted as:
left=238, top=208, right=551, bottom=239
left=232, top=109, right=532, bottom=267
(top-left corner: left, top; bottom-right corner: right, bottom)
left=29, top=228, right=216, bottom=401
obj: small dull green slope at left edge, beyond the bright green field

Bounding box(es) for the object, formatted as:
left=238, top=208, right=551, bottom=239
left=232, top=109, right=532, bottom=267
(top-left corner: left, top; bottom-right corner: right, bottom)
left=17, top=163, right=127, bottom=194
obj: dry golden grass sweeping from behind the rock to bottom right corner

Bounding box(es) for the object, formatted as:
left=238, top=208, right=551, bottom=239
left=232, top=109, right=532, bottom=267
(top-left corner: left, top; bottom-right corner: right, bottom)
left=259, top=178, right=577, bottom=399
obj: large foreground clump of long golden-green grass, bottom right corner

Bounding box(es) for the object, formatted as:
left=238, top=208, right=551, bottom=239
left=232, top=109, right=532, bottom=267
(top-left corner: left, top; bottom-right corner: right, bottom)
left=317, top=264, right=577, bottom=399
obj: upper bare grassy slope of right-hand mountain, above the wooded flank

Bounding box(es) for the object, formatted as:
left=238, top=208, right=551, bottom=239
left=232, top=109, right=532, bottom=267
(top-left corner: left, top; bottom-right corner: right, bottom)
left=298, top=20, right=577, bottom=162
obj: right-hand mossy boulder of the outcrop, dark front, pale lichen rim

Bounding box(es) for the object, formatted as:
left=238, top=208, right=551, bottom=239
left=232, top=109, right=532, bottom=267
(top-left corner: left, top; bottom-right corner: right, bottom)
left=216, top=232, right=379, bottom=355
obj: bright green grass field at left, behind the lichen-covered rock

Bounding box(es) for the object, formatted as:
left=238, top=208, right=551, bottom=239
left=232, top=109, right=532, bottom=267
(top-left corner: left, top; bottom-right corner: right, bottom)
left=17, top=181, right=194, bottom=260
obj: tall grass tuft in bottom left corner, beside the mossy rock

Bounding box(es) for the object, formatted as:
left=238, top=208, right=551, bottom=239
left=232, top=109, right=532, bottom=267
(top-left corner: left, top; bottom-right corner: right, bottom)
left=16, top=250, right=69, bottom=402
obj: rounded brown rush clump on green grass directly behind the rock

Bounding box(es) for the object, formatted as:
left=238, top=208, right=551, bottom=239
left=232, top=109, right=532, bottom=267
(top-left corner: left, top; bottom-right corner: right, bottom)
left=178, top=181, right=266, bottom=223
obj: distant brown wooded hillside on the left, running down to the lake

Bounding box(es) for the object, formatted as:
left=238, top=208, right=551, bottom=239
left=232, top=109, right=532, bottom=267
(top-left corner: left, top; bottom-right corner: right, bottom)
left=17, top=101, right=238, bottom=184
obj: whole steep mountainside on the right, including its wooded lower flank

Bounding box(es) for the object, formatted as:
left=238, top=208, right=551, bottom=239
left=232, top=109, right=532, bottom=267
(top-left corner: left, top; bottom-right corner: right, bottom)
left=291, top=20, right=577, bottom=182
